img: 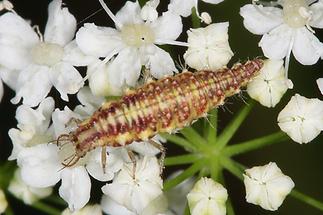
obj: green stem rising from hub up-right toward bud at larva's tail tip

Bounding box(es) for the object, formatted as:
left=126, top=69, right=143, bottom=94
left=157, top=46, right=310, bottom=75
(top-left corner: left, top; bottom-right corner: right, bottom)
left=217, top=100, right=254, bottom=150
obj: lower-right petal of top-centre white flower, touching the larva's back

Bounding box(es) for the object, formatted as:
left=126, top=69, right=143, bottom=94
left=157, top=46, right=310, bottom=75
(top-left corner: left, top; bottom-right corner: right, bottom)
left=148, top=46, right=177, bottom=79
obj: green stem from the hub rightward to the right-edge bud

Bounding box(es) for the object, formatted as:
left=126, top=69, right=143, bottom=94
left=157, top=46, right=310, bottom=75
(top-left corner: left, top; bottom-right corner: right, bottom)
left=223, top=131, right=289, bottom=157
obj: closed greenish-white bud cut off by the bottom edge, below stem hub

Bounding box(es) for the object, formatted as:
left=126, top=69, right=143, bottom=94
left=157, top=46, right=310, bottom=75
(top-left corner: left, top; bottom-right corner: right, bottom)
left=187, top=177, right=228, bottom=215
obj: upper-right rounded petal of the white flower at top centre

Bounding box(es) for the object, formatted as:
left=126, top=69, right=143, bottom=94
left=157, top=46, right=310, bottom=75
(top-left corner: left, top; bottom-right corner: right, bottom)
left=151, top=11, right=183, bottom=41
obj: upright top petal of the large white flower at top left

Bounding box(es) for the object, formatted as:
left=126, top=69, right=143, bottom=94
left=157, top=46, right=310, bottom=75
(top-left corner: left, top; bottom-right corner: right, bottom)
left=44, top=0, right=76, bottom=46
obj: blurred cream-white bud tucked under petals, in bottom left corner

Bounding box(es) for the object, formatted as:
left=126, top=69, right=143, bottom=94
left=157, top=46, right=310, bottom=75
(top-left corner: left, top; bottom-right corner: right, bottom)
left=8, top=169, right=53, bottom=205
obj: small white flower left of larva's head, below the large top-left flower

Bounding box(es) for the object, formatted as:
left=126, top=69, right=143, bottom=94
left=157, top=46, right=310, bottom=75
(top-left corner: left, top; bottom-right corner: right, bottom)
left=8, top=97, right=54, bottom=160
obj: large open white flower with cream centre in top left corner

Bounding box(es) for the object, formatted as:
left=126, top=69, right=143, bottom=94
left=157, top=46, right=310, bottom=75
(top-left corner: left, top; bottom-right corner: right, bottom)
left=0, top=0, right=92, bottom=106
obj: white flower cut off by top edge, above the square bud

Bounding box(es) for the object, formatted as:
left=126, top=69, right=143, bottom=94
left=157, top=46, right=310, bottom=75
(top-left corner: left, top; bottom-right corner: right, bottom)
left=168, top=0, right=223, bottom=24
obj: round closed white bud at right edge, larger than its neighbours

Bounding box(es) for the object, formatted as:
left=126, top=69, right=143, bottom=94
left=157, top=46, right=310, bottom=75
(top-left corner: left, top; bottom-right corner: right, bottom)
left=277, top=94, right=323, bottom=143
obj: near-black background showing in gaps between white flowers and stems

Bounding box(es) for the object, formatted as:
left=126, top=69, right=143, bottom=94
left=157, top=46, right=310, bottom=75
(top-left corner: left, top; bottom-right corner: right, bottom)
left=0, top=0, right=323, bottom=215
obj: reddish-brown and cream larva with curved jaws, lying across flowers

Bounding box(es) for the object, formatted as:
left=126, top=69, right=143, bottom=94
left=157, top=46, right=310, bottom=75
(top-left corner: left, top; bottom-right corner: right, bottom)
left=57, top=59, right=263, bottom=166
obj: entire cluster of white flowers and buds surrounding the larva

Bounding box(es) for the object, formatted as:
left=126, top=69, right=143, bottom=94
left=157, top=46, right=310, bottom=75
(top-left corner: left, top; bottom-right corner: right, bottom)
left=0, top=0, right=323, bottom=215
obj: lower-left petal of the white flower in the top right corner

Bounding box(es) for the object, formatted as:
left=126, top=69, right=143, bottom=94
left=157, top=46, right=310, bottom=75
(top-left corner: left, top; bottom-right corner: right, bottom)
left=259, top=24, right=293, bottom=60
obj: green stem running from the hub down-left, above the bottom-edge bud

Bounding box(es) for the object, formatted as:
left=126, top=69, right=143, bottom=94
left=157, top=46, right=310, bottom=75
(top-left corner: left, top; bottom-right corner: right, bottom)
left=164, top=161, right=204, bottom=191
